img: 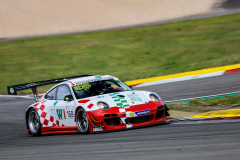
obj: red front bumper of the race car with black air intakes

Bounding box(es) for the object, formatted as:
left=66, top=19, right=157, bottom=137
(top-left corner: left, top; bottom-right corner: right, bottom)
left=87, top=101, right=166, bottom=132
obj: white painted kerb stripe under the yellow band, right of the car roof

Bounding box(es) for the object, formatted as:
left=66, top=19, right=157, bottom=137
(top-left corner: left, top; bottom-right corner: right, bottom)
left=135, top=71, right=225, bottom=88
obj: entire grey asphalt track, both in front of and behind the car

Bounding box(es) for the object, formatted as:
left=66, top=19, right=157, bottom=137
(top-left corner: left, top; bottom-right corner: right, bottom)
left=0, top=73, right=240, bottom=160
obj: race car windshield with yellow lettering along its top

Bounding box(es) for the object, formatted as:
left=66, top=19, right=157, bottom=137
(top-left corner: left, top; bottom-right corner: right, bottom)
left=73, top=79, right=132, bottom=99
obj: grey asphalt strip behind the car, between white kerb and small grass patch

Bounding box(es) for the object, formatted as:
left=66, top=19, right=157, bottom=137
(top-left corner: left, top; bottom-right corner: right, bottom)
left=136, top=73, right=240, bottom=101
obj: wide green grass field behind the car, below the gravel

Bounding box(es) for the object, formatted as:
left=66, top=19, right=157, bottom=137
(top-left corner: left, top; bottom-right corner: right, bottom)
left=0, top=14, right=240, bottom=94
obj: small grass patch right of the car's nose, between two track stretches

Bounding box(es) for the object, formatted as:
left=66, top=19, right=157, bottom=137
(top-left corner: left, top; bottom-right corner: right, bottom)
left=168, top=94, right=240, bottom=112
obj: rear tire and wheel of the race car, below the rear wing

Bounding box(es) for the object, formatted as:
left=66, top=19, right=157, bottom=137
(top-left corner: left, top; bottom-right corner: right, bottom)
left=28, top=108, right=41, bottom=136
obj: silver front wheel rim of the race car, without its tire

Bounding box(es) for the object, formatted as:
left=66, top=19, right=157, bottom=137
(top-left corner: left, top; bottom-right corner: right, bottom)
left=77, top=110, right=88, bottom=133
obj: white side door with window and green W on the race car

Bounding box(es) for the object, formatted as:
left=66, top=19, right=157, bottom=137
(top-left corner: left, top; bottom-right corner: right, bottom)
left=53, top=84, right=76, bottom=126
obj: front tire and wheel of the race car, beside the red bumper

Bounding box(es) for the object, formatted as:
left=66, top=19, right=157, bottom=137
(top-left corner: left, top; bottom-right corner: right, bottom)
left=76, top=108, right=89, bottom=134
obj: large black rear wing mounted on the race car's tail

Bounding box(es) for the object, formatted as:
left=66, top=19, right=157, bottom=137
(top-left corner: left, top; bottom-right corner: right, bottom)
left=7, top=74, right=92, bottom=99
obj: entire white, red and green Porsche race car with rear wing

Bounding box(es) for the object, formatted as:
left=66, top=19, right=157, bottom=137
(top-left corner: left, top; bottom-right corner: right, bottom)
left=8, top=75, right=169, bottom=136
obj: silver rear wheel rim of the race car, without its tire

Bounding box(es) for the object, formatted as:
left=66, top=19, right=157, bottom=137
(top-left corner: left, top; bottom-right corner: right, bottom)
left=28, top=111, right=40, bottom=133
